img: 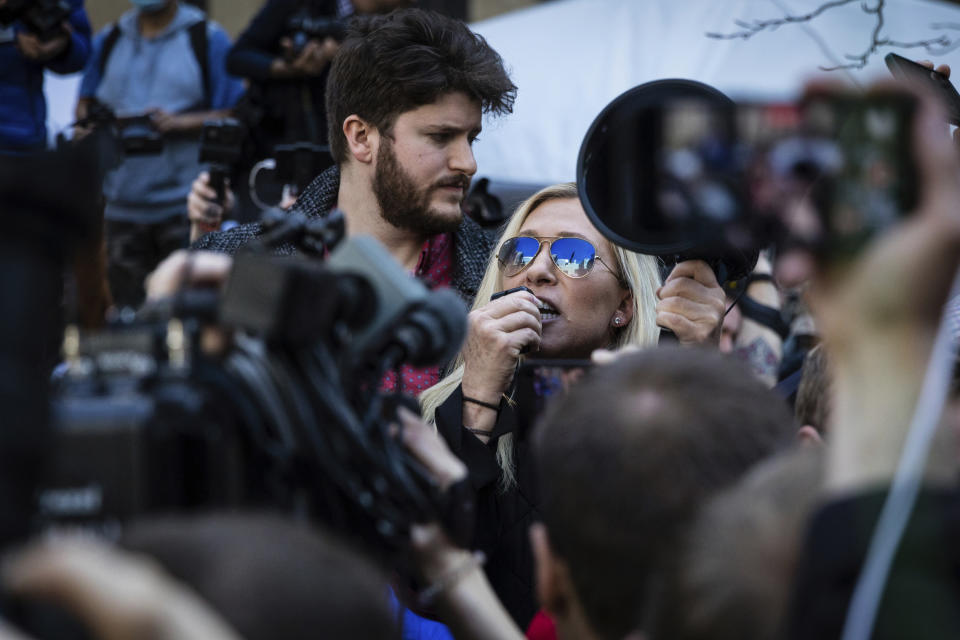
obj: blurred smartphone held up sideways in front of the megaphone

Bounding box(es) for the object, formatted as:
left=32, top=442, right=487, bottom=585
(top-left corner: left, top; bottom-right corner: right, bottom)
left=657, top=91, right=917, bottom=260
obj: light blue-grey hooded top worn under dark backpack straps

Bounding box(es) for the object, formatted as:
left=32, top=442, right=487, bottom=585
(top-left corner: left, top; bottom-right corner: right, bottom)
left=80, top=4, right=243, bottom=222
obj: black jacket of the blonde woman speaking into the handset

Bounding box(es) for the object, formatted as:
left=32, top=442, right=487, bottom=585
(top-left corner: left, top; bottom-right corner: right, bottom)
left=435, top=387, right=540, bottom=629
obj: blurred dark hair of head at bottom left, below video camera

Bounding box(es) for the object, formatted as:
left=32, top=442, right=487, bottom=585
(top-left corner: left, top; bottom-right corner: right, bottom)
left=121, top=514, right=400, bottom=640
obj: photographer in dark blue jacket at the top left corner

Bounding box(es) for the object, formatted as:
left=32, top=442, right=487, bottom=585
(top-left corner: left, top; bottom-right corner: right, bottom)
left=0, top=0, right=90, bottom=153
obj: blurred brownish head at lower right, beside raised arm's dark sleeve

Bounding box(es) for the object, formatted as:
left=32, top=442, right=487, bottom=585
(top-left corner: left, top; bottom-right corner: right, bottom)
left=650, top=447, right=825, bottom=640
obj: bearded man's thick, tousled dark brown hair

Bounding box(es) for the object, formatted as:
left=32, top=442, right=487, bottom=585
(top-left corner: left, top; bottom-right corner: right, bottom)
left=326, top=9, right=517, bottom=164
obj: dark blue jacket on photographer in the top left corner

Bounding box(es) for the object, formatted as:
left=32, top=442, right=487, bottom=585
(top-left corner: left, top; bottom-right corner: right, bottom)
left=0, top=0, right=90, bottom=153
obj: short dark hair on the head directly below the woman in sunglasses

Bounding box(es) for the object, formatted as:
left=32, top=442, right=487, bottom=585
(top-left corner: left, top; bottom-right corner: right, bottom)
left=534, top=348, right=793, bottom=639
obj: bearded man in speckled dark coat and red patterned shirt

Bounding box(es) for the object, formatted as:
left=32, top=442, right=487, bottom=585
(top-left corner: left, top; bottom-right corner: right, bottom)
left=194, top=9, right=516, bottom=395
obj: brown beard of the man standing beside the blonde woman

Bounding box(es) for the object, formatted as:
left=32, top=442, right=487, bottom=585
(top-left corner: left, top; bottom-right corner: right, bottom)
left=373, top=136, right=470, bottom=236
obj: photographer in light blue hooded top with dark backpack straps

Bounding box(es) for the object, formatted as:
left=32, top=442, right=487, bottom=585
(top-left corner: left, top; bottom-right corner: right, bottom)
left=77, top=0, right=242, bottom=306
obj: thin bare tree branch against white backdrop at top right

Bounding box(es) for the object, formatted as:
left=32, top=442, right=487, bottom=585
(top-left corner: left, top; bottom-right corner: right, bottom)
left=706, top=0, right=960, bottom=71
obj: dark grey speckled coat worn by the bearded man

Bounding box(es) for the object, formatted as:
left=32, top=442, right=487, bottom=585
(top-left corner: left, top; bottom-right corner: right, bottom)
left=192, top=166, right=496, bottom=305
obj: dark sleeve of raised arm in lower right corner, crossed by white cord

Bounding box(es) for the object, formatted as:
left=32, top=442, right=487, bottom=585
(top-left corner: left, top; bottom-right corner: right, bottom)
left=786, top=490, right=960, bottom=640
